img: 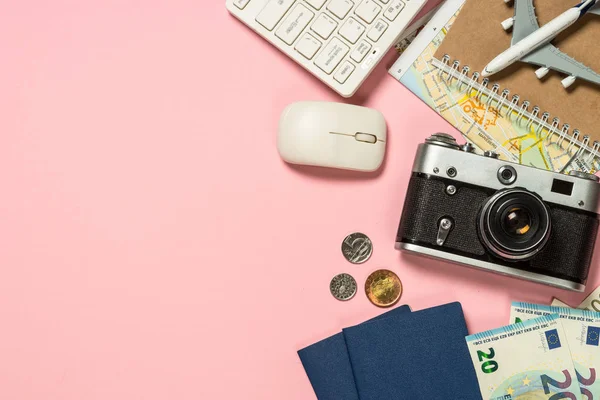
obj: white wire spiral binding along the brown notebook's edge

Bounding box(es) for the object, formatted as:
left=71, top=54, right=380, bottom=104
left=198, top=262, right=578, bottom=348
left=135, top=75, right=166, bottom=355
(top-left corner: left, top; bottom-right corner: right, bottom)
left=432, top=55, right=600, bottom=167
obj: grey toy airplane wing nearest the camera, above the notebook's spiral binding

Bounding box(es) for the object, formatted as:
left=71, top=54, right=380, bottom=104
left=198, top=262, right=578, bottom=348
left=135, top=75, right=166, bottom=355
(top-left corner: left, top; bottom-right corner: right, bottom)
left=521, top=44, right=600, bottom=84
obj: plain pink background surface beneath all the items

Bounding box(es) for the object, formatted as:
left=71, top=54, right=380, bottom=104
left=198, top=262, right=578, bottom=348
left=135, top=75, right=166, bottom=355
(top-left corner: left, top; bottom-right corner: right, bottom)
left=0, top=0, right=600, bottom=400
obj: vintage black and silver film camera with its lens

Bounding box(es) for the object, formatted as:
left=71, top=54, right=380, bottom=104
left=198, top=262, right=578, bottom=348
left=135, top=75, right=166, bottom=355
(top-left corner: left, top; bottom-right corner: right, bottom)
left=396, top=133, right=600, bottom=292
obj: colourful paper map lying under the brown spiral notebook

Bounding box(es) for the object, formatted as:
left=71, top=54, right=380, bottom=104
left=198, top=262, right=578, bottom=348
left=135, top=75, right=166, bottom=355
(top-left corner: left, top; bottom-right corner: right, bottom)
left=389, top=0, right=600, bottom=173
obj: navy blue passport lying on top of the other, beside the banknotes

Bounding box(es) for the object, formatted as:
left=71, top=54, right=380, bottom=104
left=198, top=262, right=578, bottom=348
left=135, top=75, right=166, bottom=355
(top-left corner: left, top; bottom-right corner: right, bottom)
left=343, top=303, right=481, bottom=400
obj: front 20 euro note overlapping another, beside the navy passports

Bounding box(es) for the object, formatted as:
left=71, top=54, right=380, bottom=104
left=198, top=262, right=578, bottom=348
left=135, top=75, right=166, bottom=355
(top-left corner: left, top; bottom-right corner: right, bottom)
left=466, top=315, right=583, bottom=400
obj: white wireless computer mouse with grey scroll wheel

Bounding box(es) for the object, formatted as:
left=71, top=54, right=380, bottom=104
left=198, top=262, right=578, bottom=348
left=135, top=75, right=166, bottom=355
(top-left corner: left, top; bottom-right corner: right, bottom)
left=277, top=101, right=387, bottom=171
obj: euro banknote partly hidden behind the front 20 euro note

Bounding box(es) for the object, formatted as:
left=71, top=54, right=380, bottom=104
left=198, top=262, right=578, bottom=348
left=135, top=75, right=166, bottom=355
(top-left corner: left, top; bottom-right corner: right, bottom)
left=510, top=302, right=600, bottom=400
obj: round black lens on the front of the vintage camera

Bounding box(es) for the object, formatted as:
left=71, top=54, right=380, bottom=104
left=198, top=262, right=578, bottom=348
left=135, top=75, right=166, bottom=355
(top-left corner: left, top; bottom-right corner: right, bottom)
left=478, top=189, right=551, bottom=261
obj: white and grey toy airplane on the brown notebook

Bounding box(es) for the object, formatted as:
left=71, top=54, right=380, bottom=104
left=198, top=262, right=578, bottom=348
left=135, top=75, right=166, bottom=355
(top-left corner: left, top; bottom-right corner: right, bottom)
left=481, top=0, right=600, bottom=89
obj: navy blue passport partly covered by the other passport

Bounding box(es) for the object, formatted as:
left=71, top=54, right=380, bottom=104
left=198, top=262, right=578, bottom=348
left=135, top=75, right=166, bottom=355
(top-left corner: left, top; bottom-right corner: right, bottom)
left=298, top=306, right=410, bottom=400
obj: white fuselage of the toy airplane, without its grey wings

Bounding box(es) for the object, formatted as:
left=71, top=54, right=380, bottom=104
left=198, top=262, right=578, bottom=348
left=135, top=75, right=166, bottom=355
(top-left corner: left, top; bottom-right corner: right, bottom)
left=481, top=0, right=598, bottom=77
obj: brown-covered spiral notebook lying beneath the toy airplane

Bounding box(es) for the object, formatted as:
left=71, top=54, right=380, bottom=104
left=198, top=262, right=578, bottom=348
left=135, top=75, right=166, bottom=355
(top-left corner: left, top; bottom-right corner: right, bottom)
left=432, top=0, right=600, bottom=172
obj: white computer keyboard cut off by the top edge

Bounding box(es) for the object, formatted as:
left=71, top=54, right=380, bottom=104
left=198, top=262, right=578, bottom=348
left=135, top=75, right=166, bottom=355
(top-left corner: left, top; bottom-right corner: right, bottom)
left=226, top=0, right=427, bottom=97
